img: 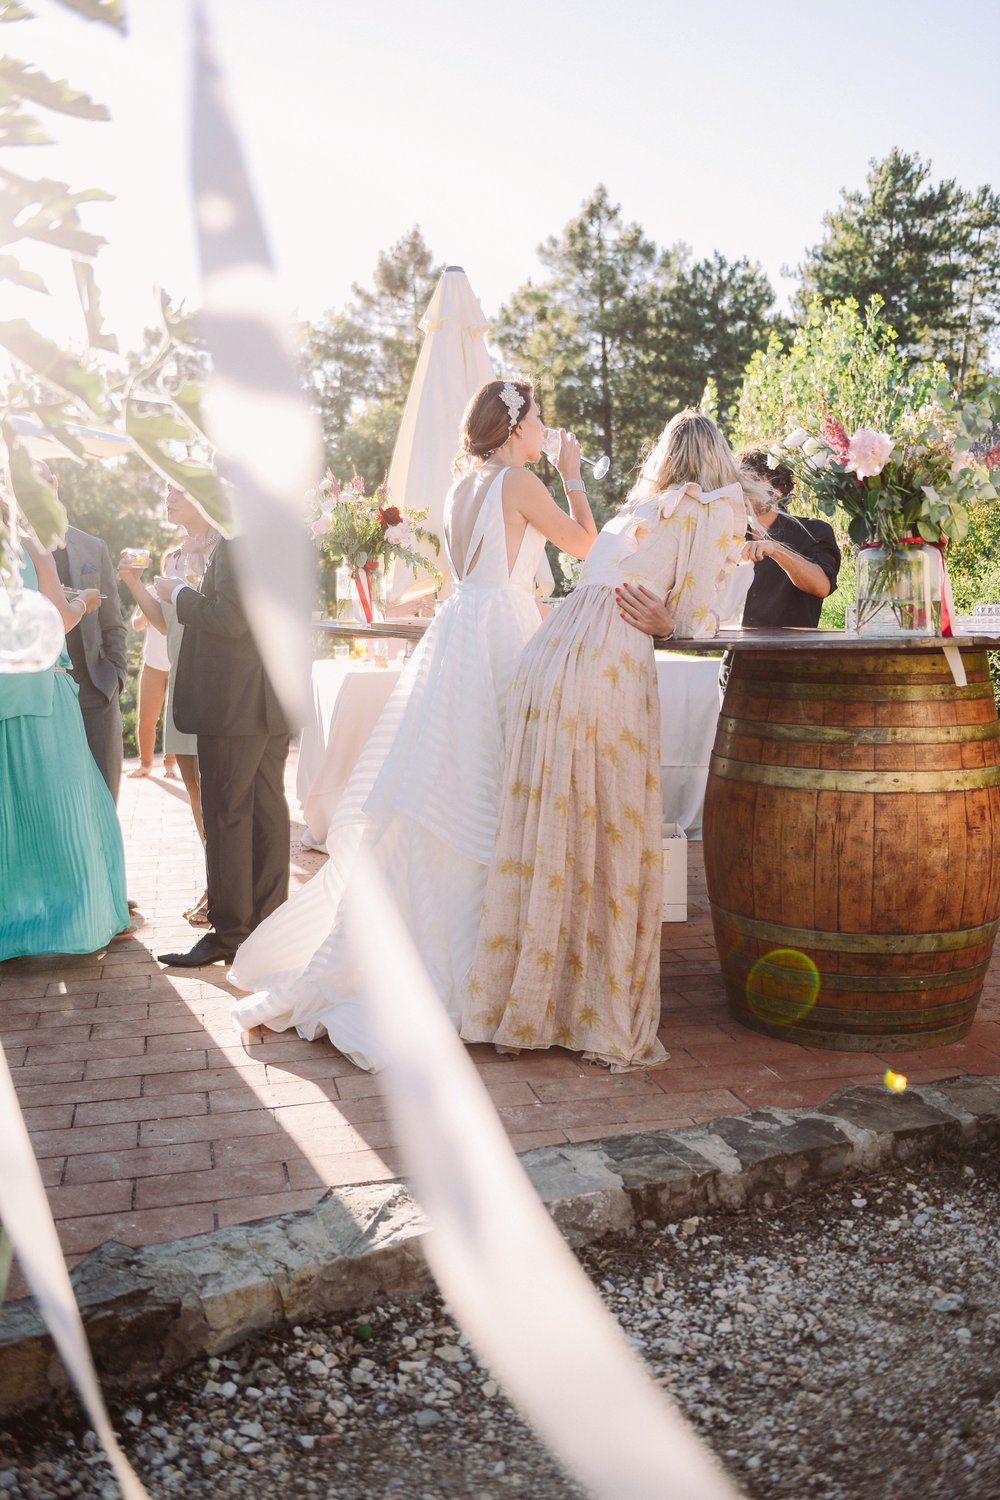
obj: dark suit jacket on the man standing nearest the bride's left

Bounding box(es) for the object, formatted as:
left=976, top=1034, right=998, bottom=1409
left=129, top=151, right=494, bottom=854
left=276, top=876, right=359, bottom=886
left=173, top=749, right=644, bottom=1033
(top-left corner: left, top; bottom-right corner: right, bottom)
left=174, top=540, right=288, bottom=735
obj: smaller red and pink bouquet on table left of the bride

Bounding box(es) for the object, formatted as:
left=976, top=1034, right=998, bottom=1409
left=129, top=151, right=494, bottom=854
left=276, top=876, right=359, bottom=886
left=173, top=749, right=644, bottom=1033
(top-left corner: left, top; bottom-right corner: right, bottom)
left=310, top=470, right=439, bottom=624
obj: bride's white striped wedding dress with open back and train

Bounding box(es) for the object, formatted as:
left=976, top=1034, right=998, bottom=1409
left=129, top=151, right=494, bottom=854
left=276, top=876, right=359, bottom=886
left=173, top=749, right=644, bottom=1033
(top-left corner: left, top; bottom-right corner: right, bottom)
left=229, top=470, right=544, bottom=1071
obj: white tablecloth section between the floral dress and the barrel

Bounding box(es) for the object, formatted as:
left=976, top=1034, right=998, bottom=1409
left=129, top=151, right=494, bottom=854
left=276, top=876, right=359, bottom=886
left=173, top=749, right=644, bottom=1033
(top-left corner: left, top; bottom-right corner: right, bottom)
left=657, top=651, right=720, bottom=839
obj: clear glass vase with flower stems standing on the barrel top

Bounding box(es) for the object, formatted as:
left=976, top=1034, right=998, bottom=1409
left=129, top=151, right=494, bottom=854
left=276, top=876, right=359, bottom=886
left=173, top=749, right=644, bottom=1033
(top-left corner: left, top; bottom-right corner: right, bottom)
left=858, top=542, right=943, bottom=636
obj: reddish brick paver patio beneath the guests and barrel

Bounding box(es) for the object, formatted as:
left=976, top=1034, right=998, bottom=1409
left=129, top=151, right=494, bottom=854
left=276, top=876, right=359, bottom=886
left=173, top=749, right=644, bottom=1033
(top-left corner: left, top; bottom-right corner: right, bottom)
left=0, top=750, right=1000, bottom=1296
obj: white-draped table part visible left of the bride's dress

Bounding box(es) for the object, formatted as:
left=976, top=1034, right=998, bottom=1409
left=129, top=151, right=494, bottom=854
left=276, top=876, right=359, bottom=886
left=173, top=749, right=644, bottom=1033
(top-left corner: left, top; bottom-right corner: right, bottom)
left=295, top=662, right=402, bottom=849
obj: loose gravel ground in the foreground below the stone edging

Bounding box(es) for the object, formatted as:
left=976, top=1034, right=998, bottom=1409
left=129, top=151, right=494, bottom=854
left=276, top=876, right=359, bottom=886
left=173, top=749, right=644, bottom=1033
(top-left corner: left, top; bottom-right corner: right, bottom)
left=0, top=1152, right=1000, bottom=1500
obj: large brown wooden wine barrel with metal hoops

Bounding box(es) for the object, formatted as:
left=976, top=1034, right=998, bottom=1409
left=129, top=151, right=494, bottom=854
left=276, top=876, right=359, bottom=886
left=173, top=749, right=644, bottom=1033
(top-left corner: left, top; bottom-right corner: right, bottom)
left=705, top=647, right=1000, bottom=1052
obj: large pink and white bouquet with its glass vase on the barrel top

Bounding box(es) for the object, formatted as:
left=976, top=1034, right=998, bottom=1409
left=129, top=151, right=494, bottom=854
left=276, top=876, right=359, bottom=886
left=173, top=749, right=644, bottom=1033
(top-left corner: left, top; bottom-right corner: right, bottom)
left=768, top=381, right=1000, bottom=636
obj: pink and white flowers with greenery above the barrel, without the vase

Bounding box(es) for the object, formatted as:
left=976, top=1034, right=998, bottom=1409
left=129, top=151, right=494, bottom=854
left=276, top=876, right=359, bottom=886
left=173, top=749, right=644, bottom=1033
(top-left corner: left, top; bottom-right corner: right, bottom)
left=768, top=381, right=1000, bottom=548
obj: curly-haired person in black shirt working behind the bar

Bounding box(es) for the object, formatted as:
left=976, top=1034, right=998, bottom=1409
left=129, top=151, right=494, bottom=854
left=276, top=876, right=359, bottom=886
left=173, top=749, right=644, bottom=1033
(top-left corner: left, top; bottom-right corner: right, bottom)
left=738, top=449, right=840, bottom=630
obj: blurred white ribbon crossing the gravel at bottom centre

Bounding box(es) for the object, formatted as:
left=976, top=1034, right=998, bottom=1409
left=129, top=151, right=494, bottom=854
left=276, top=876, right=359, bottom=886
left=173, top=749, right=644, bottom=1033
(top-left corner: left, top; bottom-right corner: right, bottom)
left=348, top=857, right=738, bottom=1500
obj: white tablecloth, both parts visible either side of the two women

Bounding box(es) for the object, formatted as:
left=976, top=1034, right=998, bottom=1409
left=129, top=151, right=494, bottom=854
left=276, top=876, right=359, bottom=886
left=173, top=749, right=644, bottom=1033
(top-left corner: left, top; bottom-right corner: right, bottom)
left=295, top=651, right=718, bottom=846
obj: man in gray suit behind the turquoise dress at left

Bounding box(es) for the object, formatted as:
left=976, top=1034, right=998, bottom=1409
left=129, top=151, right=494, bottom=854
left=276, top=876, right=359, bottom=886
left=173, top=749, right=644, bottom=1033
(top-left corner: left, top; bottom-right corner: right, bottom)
left=39, top=464, right=129, bottom=803
